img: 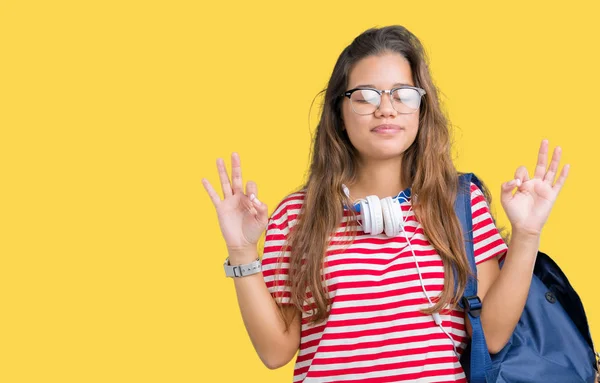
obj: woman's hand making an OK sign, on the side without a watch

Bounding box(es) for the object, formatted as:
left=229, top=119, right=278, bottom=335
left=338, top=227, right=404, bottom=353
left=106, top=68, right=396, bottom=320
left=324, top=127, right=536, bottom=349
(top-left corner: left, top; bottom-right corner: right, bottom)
left=501, top=140, right=569, bottom=235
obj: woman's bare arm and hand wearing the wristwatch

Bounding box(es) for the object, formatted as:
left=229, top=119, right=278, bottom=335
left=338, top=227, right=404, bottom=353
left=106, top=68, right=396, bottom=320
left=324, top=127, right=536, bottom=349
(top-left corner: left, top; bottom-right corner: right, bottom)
left=202, top=153, right=300, bottom=368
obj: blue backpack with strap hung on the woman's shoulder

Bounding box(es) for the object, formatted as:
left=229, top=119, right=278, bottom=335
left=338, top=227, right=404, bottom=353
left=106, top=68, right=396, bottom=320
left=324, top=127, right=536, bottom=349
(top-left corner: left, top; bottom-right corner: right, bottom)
left=454, top=173, right=600, bottom=383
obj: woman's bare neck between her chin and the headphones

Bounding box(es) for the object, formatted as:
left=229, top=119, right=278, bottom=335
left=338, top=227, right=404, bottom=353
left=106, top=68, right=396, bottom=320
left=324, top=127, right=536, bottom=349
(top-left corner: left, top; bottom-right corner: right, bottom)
left=347, top=157, right=408, bottom=200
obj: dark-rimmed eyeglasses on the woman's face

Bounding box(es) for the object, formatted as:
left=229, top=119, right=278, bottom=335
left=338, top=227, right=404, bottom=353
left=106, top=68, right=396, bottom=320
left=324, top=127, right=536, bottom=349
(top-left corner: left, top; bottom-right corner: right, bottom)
left=342, top=86, right=425, bottom=115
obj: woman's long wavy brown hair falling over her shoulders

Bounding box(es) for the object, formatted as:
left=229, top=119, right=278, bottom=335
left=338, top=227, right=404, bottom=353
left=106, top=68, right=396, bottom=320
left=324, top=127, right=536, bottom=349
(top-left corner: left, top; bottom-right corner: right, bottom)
left=276, top=26, right=491, bottom=324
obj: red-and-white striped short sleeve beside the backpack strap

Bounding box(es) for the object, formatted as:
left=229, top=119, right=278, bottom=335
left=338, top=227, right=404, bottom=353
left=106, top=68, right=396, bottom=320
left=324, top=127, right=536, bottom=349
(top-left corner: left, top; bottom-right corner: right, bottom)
left=471, top=183, right=508, bottom=265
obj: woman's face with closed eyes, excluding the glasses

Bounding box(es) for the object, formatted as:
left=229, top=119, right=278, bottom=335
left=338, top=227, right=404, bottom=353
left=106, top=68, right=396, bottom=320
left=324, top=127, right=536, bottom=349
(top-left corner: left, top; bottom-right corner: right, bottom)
left=342, top=53, right=419, bottom=160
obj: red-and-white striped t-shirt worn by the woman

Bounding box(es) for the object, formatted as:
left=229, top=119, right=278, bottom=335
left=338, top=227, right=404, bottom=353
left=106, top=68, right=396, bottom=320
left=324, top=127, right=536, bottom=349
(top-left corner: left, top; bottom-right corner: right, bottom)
left=262, top=184, right=507, bottom=383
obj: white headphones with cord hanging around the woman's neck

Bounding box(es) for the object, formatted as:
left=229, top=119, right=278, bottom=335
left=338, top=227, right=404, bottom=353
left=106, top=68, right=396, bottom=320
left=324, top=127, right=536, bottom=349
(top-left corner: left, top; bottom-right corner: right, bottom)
left=342, top=184, right=460, bottom=359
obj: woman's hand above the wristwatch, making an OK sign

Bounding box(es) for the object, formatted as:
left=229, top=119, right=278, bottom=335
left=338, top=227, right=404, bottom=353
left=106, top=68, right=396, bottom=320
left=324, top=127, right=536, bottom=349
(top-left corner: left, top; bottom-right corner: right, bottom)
left=202, top=153, right=268, bottom=254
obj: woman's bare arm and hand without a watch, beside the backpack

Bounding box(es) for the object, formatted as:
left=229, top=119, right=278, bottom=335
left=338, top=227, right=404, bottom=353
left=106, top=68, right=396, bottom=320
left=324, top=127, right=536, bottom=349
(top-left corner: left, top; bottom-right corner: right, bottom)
left=466, top=141, right=569, bottom=353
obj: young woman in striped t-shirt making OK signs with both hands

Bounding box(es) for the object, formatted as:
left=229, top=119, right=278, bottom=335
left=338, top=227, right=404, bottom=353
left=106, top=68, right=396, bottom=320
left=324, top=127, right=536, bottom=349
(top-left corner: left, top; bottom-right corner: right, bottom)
left=203, top=26, right=568, bottom=383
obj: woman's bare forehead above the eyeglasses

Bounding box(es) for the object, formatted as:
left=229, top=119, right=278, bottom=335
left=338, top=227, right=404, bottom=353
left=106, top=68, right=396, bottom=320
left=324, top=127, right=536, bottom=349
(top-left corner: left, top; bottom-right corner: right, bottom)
left=348, top=53, right=414, bottom=89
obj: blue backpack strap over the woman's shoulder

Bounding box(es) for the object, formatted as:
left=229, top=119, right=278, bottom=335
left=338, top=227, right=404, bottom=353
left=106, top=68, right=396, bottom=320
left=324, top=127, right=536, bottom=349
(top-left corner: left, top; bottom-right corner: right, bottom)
left=454, top=173, right=492, bottom=383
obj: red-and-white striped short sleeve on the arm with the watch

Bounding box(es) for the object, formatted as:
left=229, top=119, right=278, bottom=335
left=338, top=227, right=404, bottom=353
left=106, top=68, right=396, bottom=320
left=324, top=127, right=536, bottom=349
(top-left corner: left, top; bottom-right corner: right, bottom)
left=262, top=193, right=303, bottom=305
